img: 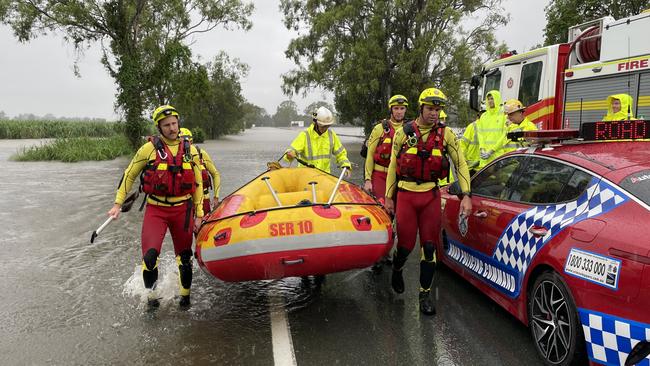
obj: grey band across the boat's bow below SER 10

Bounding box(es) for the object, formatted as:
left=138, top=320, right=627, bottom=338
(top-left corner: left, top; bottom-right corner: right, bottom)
left=201, top=230, right=388, bottom=262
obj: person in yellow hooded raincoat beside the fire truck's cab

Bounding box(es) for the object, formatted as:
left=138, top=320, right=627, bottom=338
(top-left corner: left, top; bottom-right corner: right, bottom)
left=474, top=90, right=506, bottom=169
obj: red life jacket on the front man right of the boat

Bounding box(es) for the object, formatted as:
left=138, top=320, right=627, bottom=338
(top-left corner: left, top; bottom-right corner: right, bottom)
left=397, top=121, right=449, bottom=184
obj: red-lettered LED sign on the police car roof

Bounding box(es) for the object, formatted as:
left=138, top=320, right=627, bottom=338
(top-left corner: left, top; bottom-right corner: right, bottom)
left=580, top=120, right=650, bottom=141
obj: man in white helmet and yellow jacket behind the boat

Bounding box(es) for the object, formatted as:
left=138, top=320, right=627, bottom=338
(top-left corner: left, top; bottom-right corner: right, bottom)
left=284, top=107, right=352, bottom=177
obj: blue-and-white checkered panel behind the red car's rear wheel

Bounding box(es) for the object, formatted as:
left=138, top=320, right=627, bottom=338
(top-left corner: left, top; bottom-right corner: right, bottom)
left=578, top=309, right=650, bottom=366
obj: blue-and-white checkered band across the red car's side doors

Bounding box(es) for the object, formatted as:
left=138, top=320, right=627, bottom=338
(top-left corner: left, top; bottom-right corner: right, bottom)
left=493, top=178, right=629, bottom=274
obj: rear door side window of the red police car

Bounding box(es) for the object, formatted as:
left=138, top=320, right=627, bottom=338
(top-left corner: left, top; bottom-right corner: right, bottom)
left=509, top=158, right=575, bottom=205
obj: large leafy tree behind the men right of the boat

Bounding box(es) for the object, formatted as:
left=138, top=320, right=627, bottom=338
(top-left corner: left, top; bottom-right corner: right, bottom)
left=280, top=0, right=507, bottom=131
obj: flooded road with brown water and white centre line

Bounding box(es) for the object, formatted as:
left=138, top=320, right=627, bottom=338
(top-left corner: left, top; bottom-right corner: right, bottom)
left=0, top=127, right=541, bottom=365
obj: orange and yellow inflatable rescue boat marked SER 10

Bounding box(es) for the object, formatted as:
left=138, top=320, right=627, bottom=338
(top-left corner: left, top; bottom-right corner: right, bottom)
left=196, top=167, right=393, bottom=282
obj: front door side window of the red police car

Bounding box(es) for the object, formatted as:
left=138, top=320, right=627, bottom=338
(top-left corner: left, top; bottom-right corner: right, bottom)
left=472, top=156, right=527, bottom=200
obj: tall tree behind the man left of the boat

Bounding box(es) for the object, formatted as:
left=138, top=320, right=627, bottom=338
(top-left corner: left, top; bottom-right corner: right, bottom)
left=0, top=0, right=253, bottom=147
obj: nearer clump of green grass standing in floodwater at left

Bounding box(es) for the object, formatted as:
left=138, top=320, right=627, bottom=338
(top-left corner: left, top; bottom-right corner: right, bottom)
left=11, top=135, right=133, bottom=162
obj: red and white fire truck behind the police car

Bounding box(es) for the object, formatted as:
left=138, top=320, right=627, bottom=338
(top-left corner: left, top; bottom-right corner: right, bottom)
left=470, top=10, right=650, bottom=129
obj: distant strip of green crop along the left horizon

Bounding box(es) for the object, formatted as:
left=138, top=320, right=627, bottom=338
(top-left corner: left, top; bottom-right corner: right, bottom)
left=0, top=120, right=124, bottom=139
